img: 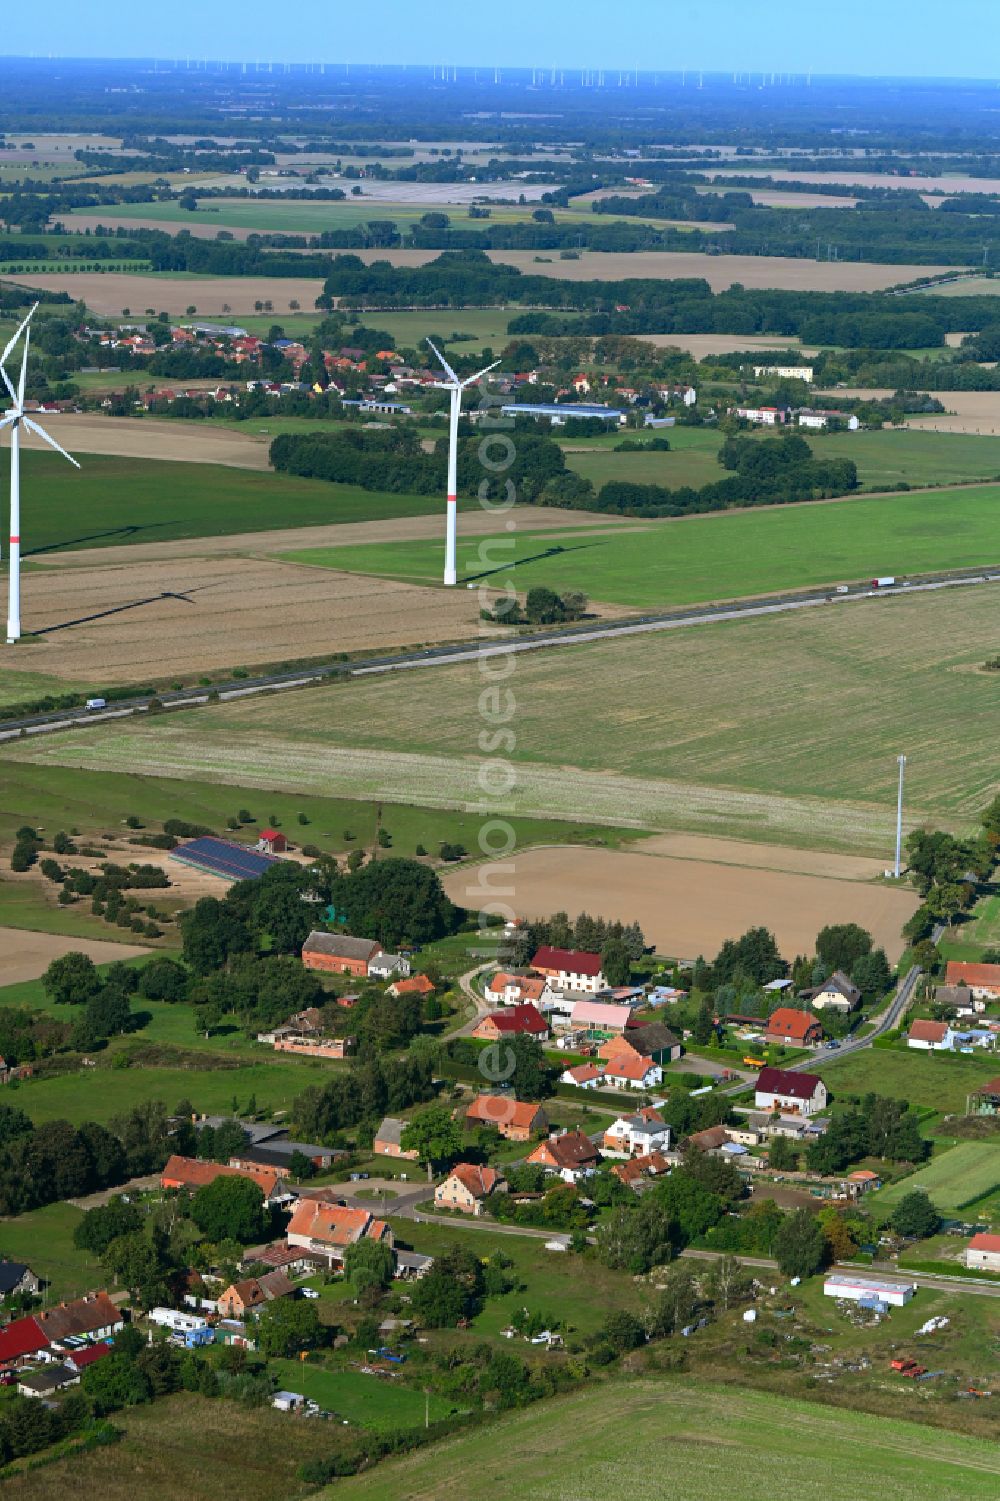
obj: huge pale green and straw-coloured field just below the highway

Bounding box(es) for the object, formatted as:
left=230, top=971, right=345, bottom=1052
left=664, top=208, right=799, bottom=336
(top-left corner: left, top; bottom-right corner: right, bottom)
left=9, top=582, right=995, bottom=862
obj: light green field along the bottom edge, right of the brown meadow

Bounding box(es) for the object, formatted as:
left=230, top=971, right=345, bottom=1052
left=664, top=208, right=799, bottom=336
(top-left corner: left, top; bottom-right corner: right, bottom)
left=330, top=1378, right=1000, bottom=1501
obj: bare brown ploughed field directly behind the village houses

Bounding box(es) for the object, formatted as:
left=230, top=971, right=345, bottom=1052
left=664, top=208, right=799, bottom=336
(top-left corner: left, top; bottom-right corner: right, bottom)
left=444, top=839, right=917, bottom=961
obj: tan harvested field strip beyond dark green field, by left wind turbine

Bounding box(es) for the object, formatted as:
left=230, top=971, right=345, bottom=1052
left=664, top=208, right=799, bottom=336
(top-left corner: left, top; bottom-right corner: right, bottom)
left=21, top=411, right=270, bottom=470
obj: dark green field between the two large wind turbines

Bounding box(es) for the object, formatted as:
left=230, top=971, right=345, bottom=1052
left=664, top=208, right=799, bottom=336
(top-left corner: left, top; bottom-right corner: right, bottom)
left=0, top=453, right=438, bottom=558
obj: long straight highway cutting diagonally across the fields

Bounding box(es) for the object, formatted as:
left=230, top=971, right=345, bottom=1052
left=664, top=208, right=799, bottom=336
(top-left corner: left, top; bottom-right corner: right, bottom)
left=0, top=570, right=1000, bottom=740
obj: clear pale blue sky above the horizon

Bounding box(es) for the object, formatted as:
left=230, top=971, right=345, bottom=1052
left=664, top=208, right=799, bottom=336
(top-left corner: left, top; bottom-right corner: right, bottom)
left=3, top=0, right=1000, bottom=78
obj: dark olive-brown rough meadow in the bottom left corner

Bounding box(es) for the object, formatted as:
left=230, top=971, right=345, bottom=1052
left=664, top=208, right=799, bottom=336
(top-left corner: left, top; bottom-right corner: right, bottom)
left=12, top=1391, right=339, bottom=1501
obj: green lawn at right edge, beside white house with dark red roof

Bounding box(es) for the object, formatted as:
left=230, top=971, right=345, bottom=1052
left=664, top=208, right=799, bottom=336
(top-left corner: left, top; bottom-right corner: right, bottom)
left=817, top=1048, right=1000, bottom=1122
